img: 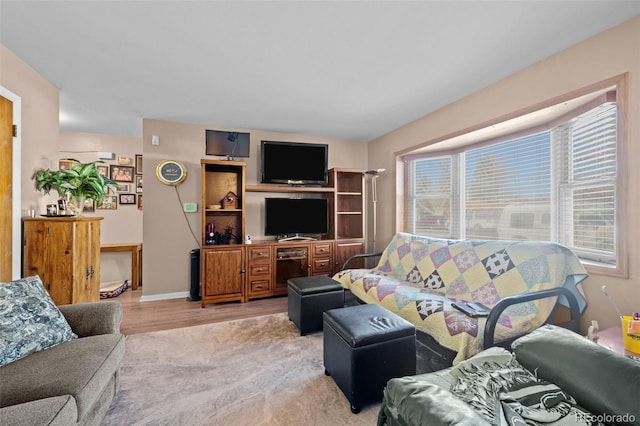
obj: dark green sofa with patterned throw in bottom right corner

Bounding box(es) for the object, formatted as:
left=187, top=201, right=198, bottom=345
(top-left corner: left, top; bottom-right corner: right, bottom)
left=378, top=325, right=640, bottom=426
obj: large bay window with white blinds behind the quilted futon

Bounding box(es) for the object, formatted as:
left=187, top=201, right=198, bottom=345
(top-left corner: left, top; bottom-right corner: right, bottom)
left=405, top=81, right=621, bottom=272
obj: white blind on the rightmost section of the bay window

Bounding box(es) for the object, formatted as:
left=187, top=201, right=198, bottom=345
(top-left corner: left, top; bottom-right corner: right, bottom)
left=553, top=102, right=617, bottom=264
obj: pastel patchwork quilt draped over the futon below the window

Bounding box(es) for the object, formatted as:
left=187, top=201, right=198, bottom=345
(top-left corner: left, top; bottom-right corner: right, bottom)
left=334, top=233, right=587, bottom=364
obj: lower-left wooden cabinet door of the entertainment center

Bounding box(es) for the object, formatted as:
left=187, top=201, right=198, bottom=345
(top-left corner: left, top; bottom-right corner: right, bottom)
left=202, top=246, right=245, bottom=306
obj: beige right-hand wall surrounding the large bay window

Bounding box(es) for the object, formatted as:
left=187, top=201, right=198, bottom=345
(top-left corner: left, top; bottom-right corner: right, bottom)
left=369, top=17, right=640, bottom=331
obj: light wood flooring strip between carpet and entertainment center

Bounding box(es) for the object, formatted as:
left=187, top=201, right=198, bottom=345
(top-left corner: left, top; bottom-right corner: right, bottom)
left=102, top=288, right=287, bottom=335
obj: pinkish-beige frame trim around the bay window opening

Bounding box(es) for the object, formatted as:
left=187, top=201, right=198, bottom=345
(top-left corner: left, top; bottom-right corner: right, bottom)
left=396, top=74, right=629, bottom=278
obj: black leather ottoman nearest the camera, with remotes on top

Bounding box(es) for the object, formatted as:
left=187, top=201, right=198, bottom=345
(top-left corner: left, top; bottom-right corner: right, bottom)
left=323, top=305, right=416, bottom=414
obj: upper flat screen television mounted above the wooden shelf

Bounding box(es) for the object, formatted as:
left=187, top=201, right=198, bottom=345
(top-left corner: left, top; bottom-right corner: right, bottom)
left=260, top=141, right=329, bottom=186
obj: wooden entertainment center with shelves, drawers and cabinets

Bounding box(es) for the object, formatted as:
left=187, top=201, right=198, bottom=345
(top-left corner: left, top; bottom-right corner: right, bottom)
left=200, top=159, right=365, bottom=307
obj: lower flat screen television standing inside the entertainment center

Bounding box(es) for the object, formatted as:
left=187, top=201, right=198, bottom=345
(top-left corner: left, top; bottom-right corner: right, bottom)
left=264, top=198, right=329, bottom=241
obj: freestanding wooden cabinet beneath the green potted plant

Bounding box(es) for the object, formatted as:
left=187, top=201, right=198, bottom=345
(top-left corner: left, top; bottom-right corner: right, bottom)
left=23, top=217, right=102, bottom=305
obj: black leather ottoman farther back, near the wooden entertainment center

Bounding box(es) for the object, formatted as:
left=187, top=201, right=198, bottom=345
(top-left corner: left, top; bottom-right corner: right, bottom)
left=287, top=275, right=344, bottom=336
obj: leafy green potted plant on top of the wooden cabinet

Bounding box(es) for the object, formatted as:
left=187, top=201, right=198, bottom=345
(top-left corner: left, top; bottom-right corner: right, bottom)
left=31, top=159, right=117, bottom=214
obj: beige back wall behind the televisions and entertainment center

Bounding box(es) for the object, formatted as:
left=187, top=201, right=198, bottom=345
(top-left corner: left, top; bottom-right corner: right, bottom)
left=142, top=119, right=367, bottom=300
